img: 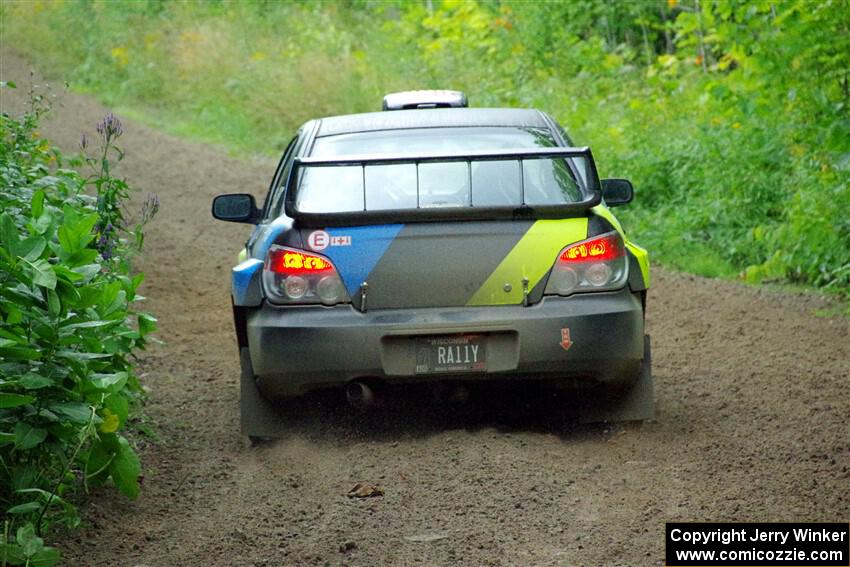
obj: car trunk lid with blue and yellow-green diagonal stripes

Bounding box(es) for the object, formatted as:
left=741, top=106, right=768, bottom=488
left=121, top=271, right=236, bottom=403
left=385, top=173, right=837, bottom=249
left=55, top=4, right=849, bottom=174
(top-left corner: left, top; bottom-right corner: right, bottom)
left=301, top=217, right=587, bottom=310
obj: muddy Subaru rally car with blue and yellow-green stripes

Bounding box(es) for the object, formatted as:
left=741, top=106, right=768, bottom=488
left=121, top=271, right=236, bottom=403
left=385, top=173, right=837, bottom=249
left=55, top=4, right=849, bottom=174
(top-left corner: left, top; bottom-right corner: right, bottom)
left=213, top=91, right=653, bottom=437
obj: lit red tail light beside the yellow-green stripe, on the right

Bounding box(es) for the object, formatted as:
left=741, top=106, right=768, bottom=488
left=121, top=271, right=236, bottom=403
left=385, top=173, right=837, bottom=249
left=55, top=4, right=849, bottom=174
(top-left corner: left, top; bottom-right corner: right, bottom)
left=544, top=232, right=629, bottom=295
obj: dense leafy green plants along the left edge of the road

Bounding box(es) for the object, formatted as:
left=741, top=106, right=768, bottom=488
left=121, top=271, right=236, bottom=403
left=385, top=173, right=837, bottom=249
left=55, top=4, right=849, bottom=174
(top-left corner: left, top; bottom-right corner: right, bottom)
left=0, top=86, right=158, bottom=567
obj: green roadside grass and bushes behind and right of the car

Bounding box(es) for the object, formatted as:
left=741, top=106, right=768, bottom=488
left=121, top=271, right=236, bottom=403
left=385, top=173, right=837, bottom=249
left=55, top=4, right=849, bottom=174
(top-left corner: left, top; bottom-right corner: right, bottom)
left=0, top=0, right=850, bottom=302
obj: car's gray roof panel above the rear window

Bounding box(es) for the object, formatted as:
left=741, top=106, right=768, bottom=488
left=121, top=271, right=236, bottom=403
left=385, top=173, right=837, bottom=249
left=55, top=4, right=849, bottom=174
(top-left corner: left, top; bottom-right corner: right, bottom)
left=316, top=108, right=548, bottom=136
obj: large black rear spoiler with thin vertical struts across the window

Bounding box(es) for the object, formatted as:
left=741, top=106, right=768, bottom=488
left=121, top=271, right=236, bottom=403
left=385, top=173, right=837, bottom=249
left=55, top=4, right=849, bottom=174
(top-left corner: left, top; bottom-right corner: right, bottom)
left=284, top=147, right=602, bottom=227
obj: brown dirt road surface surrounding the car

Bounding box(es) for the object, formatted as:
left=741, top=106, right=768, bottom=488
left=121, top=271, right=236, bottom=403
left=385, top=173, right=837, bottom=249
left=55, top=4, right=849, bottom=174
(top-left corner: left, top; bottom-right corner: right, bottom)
left=2, top=51, right=850, bottom=567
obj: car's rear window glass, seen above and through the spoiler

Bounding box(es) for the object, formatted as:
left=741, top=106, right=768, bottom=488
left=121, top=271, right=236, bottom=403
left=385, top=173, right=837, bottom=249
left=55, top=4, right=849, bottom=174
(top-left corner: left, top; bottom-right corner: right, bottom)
left=296, top=127, right=584, bottom=213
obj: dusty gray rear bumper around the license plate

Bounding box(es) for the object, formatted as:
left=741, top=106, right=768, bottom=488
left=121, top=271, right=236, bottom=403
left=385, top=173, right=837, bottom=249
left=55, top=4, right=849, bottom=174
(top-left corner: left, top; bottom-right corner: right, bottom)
left=247, top=288, right=644, bottom=397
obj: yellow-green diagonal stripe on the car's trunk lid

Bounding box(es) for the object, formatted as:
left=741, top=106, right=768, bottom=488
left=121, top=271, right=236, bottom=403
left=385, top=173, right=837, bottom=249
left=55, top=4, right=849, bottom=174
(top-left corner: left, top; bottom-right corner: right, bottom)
left=467, top=217, right=587, bottom=305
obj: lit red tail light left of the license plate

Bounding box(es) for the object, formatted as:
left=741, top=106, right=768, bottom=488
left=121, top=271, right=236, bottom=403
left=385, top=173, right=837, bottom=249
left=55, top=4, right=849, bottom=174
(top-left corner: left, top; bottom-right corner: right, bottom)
left=263, top=246, right=351, bottom=305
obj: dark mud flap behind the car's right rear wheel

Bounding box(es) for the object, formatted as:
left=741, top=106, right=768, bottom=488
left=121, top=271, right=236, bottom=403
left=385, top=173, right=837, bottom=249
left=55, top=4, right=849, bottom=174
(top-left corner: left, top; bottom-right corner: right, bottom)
left=579, top=335, right=655, bottom=423
